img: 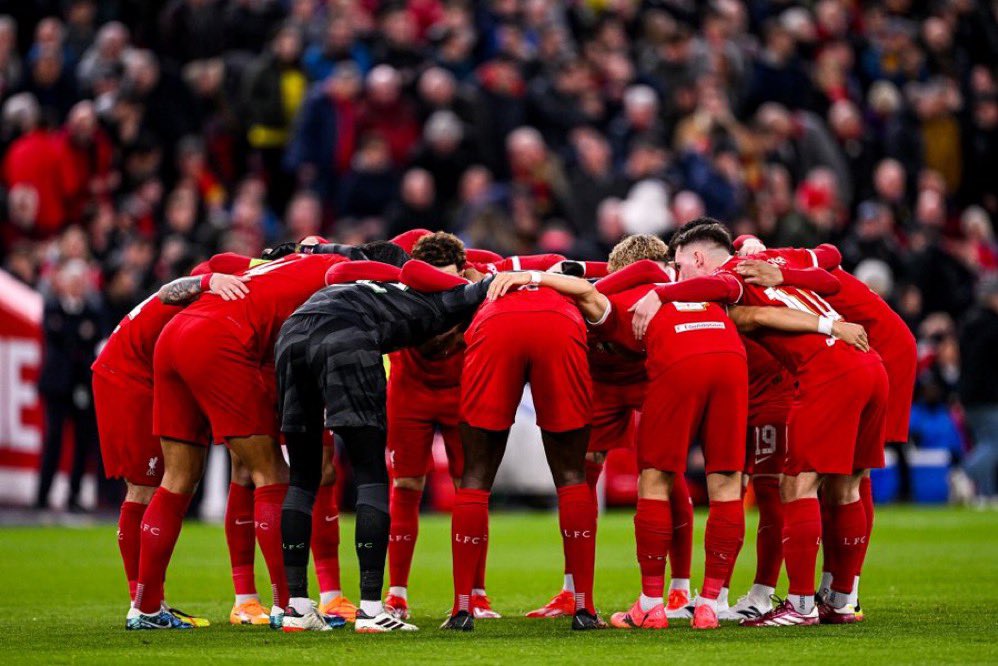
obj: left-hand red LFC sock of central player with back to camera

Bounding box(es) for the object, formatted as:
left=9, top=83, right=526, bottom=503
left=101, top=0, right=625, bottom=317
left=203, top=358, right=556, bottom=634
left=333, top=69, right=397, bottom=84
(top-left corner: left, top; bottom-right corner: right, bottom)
left=451, top=488, right=490, bottom=613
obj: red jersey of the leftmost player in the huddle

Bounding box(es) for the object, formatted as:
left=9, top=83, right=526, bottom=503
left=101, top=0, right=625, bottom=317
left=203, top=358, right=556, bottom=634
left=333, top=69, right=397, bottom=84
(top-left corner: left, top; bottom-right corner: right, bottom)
left=93, top=252, right=252, bottom=387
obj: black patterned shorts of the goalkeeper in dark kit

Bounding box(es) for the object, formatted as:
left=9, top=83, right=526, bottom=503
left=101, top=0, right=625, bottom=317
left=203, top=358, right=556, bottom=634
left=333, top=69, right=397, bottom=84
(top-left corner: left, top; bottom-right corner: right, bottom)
left=274, top=315, right=387, bottom=433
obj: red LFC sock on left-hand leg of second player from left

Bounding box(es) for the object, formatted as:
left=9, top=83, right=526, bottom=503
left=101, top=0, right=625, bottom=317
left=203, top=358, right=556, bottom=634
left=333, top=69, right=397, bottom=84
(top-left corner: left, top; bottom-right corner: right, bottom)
left=135, top=486, right=192, bottom=615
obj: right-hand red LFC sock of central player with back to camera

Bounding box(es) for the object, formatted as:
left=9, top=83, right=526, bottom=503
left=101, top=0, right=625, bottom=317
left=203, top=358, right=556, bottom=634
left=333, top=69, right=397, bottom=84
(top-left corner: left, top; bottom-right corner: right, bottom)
left=558, top=483, right=597, bottom=613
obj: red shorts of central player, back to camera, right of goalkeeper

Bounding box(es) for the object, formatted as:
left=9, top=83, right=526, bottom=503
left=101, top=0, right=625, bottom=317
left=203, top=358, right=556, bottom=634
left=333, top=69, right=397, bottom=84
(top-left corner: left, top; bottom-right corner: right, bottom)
left=461, top=310, right=592, bottom=432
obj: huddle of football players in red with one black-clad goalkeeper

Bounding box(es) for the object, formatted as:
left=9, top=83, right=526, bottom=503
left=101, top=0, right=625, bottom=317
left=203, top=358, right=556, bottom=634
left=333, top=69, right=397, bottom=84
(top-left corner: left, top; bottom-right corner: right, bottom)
left=94, top=218, right=916, bottom=633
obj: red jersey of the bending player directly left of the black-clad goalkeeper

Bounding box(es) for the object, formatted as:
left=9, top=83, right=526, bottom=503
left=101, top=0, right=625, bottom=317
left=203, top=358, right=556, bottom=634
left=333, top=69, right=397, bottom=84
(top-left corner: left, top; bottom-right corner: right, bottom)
left=180, top=254, right=348, bottom=363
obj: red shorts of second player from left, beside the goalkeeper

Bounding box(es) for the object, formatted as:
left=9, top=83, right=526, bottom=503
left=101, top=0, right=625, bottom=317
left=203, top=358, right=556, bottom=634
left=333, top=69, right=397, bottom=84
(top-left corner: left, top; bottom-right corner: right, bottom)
left=153, top=314, right=278, bottom=444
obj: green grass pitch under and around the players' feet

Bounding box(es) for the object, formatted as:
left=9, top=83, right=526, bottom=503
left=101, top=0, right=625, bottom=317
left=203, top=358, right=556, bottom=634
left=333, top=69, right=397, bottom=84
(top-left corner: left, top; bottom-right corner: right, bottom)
left=0, top=507, right=998, bottom=666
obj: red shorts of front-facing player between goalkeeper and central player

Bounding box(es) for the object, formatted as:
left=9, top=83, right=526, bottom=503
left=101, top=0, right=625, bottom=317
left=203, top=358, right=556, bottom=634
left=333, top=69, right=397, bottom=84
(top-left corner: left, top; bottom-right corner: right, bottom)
left=388, top=379, right=464, bottom=478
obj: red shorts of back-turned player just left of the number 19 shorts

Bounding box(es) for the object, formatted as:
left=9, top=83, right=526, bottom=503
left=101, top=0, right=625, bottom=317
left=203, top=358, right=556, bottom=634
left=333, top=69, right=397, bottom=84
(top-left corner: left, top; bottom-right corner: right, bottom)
left=637, top=353, right=748, bottom=474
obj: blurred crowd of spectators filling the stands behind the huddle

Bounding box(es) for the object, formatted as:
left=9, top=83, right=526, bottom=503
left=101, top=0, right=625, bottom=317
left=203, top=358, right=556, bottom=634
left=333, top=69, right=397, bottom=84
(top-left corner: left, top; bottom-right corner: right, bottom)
left=0, top=0, right=998, bottom=506
